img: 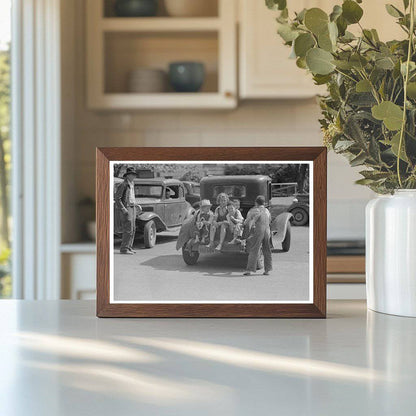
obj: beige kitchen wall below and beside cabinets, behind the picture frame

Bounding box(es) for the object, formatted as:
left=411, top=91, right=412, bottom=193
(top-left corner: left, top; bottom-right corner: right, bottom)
left=63, top=0, right=371, bottom=241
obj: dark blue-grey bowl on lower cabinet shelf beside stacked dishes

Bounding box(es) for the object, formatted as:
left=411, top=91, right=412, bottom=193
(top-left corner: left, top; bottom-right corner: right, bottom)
left=169, top=62, right=205, bottom=92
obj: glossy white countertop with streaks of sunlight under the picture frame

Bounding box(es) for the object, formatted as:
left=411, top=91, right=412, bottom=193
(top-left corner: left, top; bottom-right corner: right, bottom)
left=0, top=301, right=416, bottom=416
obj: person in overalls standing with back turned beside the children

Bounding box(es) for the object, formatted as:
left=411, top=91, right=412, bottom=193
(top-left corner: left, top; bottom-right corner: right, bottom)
left=244, top=195, right=273, bottom=276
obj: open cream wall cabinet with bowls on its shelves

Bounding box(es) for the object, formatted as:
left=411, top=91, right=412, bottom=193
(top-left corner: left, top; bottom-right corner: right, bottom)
left=86, top=0, right=237, bottom=109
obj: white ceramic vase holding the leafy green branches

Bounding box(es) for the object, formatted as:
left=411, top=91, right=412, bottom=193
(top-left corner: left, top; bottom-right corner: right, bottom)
left=366, top=190, right=416, bottom=317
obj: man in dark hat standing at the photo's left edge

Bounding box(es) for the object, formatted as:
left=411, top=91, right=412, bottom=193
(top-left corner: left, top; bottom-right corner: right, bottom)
left=115, top=167, right=142, bottom=254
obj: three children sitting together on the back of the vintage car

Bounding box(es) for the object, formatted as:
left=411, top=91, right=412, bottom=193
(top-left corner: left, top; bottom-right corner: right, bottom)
left=194, top=194, right=244, bottom=251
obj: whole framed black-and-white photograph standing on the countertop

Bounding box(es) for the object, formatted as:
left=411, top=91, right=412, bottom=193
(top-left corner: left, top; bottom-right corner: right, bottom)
left=96, top=147, right=327, bottom=318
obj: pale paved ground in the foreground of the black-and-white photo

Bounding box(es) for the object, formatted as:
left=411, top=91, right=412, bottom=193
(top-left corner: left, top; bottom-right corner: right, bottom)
left=114, top=227, right=309, bottom=301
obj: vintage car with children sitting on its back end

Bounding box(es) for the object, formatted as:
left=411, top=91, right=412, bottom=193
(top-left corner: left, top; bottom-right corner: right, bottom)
left=176, top=175, right=292, bottom=265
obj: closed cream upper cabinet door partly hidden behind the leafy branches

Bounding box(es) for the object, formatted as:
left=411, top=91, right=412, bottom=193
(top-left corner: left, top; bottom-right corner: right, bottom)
left=239, top=0, right=404, bottom=99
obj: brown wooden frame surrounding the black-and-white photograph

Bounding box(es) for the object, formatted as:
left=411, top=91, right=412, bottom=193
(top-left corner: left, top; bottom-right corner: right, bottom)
left=96, top=147, right=327, bottom=318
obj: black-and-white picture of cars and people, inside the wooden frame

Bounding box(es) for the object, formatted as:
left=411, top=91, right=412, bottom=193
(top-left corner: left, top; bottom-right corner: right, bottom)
left=110, top=161, right=313, bottom=304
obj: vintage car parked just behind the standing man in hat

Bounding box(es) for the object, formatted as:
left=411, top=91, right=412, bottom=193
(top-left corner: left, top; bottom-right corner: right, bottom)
left=114, top=178, right=195, bottom=248
